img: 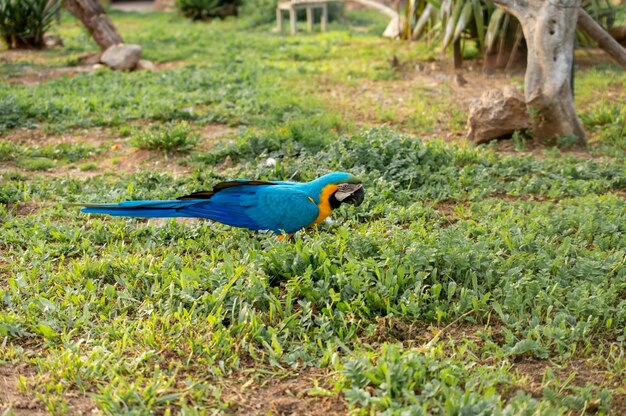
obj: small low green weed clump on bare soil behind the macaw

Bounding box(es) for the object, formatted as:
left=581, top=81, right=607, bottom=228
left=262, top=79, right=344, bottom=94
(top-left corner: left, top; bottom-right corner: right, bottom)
left=130, top=121, right=198, bottom=154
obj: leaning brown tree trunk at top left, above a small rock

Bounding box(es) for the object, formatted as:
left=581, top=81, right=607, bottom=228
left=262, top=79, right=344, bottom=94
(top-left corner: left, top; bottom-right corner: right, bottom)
left=64, top=0, right=123, bottom=51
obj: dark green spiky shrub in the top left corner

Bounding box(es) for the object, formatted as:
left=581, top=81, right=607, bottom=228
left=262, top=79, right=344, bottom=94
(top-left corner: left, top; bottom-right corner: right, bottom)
left=0, top=0, right=61, bottom=49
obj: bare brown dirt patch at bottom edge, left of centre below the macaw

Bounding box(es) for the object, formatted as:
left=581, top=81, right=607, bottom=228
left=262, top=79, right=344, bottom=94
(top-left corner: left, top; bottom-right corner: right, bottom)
left=222, top=368, right=347, bottom=416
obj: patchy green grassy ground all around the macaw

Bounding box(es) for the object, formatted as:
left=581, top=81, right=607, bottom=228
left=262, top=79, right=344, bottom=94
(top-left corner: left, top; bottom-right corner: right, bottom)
left=0, top=7, right=626, bottom=415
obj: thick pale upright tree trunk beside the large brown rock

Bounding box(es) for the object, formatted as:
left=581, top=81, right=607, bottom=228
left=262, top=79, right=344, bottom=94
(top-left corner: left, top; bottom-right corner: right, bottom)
left=495, top=0, right=585, bottom=143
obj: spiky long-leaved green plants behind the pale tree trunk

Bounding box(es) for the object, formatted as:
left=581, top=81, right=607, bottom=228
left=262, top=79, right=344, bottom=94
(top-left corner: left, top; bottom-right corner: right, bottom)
left=402, top=0, right=626, bottom=68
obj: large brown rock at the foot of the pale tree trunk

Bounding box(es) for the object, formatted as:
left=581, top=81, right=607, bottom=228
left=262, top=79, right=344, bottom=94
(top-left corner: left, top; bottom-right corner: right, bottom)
left=467, top=87, right=531, bottom=144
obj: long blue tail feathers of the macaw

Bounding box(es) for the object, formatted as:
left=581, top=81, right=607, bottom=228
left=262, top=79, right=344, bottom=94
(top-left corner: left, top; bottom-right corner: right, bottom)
left=81, top=200, right=198, bottom=218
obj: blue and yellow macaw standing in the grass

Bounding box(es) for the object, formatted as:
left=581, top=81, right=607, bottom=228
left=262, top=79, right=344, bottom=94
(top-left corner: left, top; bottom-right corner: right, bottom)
left=79, top=172, right=365, bottom=235
